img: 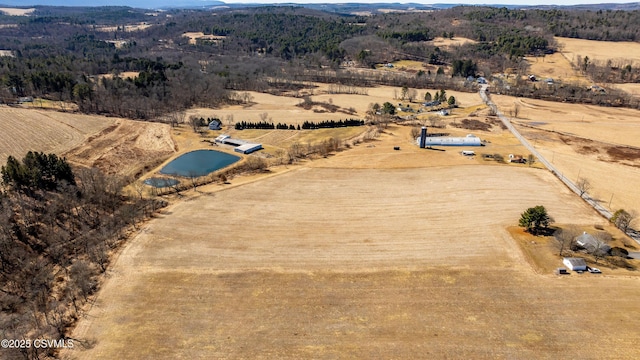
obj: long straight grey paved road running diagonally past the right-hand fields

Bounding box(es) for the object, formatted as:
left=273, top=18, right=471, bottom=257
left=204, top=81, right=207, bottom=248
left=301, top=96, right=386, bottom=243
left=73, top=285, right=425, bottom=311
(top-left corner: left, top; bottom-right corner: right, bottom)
left=480, top=85, right=616, bottom=222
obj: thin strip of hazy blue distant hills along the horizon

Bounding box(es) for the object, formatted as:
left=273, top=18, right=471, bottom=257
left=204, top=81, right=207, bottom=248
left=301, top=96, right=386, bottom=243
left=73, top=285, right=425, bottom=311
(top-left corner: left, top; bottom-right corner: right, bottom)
left=0, top=0, right=640, bottom=14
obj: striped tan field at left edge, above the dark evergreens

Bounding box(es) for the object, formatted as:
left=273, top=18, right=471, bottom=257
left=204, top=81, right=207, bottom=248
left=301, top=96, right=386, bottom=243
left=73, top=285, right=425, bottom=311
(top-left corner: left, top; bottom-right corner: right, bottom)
left=0, top=106, right=115, bottom=164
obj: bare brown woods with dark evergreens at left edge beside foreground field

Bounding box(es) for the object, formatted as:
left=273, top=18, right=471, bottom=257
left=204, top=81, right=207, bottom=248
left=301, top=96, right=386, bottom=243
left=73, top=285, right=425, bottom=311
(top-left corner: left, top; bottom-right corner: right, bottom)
left=0, top=152, right=164, bottom=359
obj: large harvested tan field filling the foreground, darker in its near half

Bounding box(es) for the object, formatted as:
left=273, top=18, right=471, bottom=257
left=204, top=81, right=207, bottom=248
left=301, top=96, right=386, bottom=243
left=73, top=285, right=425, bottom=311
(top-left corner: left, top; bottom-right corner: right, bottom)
left=63, top=164, right=640, bottom=359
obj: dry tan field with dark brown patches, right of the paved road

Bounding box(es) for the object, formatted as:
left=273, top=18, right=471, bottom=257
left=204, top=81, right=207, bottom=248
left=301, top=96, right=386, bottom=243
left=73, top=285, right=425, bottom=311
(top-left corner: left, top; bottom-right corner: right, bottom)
left=492, top=95, right=640, bottom=219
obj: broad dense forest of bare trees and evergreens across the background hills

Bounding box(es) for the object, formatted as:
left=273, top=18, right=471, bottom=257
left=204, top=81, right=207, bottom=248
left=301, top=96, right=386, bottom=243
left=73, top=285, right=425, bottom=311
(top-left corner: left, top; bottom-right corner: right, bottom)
left=0, top=6, right=640, bottom=120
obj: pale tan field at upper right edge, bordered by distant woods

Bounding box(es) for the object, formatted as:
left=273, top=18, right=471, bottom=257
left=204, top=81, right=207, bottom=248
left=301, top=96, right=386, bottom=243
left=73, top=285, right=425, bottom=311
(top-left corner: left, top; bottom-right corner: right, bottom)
left=555, top=37, right=640, bottom=66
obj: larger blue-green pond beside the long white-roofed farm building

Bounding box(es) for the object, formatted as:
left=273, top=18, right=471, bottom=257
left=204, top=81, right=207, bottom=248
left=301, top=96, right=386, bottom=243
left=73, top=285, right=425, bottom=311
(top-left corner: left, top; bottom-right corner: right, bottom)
left=160, top=150, right=240, bottom=177
